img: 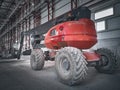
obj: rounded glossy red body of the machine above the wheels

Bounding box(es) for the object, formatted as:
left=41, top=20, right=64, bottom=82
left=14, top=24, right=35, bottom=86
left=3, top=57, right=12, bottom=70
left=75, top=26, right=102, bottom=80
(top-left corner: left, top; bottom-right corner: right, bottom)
left=45, top=18, right=97, bottom=49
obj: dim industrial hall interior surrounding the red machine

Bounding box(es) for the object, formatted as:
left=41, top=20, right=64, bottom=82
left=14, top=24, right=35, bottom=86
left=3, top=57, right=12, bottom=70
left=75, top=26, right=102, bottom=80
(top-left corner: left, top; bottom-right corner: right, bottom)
left=0, top=0, right=120, bottom=90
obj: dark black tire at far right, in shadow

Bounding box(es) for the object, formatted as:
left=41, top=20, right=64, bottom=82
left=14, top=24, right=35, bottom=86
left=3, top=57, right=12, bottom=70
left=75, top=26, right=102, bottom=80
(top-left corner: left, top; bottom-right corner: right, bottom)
left=95, top=48, right=117, bottom=74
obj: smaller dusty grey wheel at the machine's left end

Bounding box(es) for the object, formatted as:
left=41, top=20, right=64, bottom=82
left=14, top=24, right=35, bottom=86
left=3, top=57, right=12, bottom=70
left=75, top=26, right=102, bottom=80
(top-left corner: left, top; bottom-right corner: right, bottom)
left=30, top=49, right=45, bottom=70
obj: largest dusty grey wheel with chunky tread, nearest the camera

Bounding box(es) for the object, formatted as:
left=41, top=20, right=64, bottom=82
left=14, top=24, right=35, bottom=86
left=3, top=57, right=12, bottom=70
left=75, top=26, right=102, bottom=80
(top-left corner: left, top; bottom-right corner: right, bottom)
left=55, top=47, right=88, bottom=86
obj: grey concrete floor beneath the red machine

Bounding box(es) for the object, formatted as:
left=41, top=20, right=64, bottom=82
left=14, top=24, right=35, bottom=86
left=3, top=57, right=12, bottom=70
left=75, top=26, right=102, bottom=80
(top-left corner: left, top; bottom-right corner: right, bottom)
left=0, top=57, right=120, bottom=90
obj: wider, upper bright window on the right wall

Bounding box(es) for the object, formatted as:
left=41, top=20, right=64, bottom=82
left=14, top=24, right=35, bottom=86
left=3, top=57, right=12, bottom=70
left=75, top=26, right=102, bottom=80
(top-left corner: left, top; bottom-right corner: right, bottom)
left=95, top=7, right=113, bottom=20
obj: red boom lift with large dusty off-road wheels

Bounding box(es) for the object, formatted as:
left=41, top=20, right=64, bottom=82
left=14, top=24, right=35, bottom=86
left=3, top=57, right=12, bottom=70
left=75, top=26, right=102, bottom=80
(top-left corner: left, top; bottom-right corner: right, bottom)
left=18, top=7, right=116, bottom=85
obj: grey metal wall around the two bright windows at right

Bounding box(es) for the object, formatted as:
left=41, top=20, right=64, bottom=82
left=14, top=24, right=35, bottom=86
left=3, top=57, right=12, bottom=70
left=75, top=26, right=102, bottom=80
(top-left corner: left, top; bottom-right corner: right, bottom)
left=91, top=0, right=120, bottom=64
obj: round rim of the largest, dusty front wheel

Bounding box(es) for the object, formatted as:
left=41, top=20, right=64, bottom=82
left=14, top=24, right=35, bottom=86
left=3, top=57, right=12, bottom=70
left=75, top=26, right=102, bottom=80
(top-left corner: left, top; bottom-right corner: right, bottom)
left=60, top=57, right=70, bottom=74
